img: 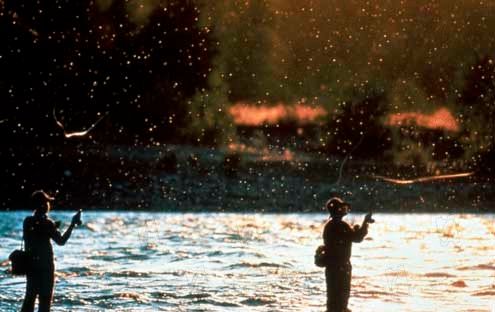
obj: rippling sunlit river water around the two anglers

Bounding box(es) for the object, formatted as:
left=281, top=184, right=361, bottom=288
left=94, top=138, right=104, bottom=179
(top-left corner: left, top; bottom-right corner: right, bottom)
left=0, top=212, right=495, bottom=312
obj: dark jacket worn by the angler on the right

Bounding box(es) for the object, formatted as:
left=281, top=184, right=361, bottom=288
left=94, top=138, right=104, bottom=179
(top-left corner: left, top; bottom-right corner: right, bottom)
left=323, top=219, right=368, bottom=265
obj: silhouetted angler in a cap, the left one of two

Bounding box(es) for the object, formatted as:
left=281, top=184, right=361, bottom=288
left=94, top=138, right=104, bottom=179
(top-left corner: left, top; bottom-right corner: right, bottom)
left=21, top=191, right=81, bottom=312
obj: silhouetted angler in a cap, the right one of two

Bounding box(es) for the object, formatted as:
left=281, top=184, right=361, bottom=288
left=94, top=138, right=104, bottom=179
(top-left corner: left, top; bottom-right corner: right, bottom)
left=323, top=197, right=374, bottom=312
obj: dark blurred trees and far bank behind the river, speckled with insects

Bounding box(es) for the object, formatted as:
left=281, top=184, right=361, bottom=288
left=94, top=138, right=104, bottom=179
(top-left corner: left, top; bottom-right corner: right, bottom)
left=0, top=0, right=495, bottom=212
